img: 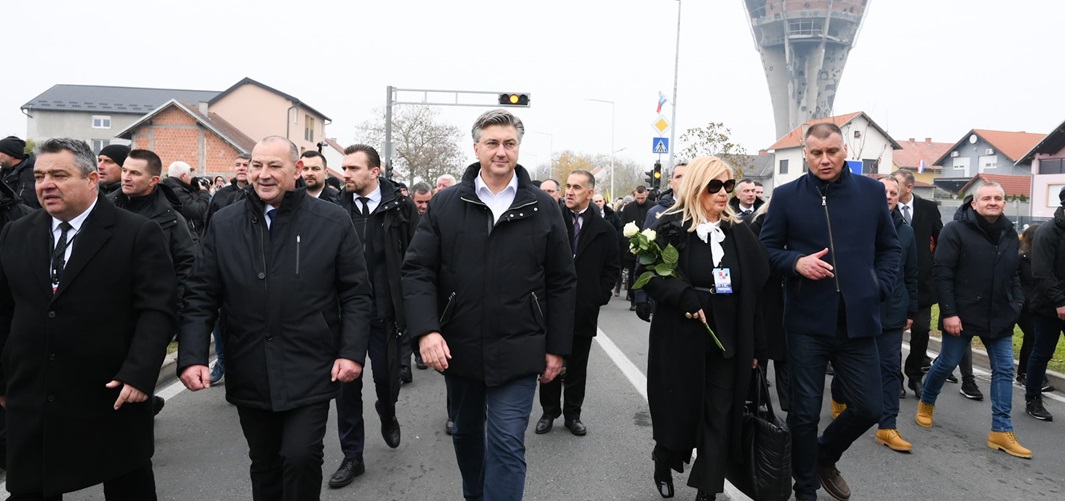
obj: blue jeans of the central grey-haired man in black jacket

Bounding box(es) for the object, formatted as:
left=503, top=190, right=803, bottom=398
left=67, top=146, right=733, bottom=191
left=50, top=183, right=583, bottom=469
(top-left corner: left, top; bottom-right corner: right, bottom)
left=444, top=375, right=537, bottom=501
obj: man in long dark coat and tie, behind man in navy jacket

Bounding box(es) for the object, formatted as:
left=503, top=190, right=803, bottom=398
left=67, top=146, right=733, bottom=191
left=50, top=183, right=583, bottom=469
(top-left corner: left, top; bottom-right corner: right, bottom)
left=891, top=171, right=943, bottom=398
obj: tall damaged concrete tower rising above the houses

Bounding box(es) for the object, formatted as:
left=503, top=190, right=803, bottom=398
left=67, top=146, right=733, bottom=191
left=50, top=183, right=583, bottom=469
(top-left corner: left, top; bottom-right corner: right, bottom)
left=743, top=0, right=869, bottom=138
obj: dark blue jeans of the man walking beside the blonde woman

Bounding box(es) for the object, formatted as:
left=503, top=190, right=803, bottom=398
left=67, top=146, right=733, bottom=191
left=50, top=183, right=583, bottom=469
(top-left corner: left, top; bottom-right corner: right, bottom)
left=788, top=324, right=877, bottom=495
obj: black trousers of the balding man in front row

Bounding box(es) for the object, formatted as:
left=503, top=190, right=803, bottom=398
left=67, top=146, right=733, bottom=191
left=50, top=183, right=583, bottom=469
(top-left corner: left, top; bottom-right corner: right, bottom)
left=236, top=401, right=329, bottom=501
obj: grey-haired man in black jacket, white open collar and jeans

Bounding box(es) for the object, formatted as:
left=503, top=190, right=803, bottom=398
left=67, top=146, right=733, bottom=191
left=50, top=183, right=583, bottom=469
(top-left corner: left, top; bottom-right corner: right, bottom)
left=403, top=110, right=577, bottom=499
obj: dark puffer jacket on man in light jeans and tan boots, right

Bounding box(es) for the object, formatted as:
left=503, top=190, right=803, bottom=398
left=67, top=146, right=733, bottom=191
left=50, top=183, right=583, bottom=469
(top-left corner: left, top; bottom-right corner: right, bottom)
left=933, top=203, right=1025, bottom=338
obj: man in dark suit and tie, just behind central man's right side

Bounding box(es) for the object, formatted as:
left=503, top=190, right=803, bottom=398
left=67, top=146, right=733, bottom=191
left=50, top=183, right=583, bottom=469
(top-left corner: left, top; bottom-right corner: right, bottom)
left=536, top=171, right=621, bottom=437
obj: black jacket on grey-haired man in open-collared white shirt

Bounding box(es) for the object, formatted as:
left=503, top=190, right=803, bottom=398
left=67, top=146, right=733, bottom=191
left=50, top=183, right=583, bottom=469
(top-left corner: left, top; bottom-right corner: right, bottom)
left=403, top=163, right=577, bottom=386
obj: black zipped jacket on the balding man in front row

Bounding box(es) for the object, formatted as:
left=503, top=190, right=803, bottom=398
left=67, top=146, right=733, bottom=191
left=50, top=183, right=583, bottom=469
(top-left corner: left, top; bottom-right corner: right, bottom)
left=185, top=190, right=371, bottom=411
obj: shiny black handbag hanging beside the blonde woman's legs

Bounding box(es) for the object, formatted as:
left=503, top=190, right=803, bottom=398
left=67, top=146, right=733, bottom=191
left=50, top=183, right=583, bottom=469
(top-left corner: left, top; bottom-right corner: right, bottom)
left=730, top=367, right=791, bottom=501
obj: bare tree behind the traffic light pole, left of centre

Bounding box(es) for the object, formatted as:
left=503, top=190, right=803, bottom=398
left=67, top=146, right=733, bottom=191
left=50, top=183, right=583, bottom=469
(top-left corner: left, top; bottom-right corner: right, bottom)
left=356, top=106, right=462, bottom=185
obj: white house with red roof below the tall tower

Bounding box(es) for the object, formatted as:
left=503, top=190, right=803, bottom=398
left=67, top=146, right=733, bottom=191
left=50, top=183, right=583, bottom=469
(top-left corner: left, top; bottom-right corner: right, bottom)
left=767, top=111, right=902, bottom=187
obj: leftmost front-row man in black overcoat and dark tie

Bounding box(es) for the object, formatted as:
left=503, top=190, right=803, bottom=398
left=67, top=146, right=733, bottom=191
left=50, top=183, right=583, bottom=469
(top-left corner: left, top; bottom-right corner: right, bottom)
left=0, top=139, right=178, bottom=500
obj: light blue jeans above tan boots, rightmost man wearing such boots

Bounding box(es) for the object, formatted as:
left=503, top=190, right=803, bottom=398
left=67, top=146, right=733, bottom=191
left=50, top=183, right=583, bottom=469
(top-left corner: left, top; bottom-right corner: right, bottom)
left=921, top=334, right=1013, bottom=432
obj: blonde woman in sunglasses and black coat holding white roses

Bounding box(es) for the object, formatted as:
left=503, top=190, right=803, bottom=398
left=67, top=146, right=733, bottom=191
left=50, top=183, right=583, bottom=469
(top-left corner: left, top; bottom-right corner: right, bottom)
left=641, top=157, right=769, bottom=500
